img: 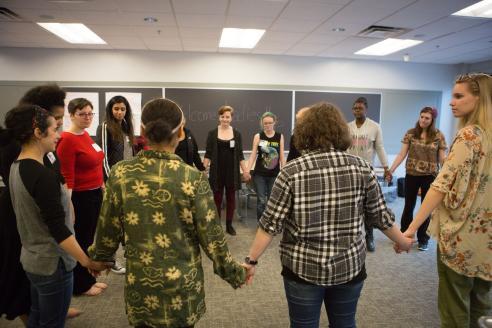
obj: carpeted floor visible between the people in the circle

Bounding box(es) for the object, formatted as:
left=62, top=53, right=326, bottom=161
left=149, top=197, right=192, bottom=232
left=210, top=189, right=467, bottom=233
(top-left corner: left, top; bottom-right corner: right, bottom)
left=0, top=198, right=439, bottom=328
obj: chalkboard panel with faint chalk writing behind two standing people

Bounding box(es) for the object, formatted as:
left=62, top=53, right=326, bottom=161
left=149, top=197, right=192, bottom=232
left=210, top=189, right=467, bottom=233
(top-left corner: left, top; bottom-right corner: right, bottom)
left=165, top=88, right=292, bottom=150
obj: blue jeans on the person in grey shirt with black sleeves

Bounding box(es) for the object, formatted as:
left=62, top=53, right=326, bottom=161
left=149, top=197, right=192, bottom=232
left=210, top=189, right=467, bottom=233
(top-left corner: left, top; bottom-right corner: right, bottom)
left=26, top=260, right=73, bottom=328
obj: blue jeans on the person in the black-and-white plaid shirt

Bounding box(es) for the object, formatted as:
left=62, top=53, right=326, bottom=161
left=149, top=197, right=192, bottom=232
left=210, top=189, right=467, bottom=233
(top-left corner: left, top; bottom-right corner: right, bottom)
left=284, top=277, right=364, bottom=328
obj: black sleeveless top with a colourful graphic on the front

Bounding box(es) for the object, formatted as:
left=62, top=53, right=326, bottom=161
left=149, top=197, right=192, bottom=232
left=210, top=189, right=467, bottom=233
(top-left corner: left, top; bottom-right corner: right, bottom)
left=255, top=132, right=282, bottom=177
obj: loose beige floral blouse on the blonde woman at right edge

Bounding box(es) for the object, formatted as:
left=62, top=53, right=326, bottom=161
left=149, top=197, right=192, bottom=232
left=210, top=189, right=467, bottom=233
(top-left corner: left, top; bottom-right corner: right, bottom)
left=428, top=125, right=492, bottom=281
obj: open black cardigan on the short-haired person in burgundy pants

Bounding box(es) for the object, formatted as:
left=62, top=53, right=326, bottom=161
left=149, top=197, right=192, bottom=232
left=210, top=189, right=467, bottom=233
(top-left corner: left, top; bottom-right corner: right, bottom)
left=205, top=128, right=244, bottom=191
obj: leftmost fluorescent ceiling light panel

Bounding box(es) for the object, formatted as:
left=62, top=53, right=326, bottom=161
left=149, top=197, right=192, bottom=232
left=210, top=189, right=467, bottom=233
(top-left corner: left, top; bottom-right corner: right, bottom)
left=37, top=23, right=106, bottom=44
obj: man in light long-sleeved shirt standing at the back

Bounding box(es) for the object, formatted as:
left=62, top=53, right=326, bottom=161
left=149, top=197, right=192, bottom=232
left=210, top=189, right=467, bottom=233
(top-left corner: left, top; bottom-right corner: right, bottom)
left=347, top=97, right=390, bottom=252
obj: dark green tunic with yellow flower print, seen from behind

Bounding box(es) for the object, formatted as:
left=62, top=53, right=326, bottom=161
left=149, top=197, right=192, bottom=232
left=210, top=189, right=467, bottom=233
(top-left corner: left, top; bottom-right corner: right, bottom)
left=89, top=150, right=245, bottom=327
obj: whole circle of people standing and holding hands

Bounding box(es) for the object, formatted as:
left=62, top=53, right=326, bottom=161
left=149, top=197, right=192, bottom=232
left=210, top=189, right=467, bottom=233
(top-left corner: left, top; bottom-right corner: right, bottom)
left=0, top=73, right=492, bottom=327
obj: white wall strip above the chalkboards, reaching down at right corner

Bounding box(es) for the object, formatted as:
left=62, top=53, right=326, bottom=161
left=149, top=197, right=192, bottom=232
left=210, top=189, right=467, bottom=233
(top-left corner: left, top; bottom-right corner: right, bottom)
left=0, top=48, right=463, bottom=165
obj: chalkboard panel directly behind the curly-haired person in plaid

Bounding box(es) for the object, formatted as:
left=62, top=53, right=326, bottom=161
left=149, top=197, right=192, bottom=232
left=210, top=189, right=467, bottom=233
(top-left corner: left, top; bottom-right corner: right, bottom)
left=295, top=91, right=381, bottom=122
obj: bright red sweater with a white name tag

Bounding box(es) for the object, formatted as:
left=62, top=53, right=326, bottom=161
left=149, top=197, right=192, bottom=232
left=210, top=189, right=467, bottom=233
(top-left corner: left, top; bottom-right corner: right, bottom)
left=56, top=131, right=104, bottom=191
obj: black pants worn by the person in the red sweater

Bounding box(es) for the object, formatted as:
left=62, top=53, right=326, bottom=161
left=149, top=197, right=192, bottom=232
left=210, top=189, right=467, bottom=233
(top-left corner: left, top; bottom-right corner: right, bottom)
left=72, top=188, right=102, bottom=295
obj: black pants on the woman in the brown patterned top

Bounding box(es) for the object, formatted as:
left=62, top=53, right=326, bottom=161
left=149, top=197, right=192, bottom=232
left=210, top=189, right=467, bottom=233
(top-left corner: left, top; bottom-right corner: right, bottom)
left=401, top=174, right=435, bottom=243
